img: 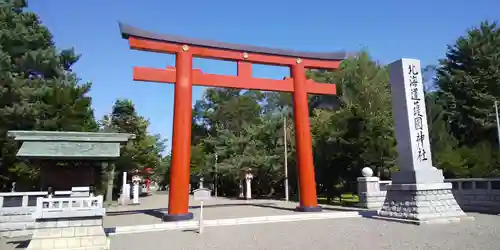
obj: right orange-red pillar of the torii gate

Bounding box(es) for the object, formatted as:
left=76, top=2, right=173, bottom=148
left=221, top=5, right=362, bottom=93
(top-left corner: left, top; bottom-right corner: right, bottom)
left=291, top=62, right=321, bottom=212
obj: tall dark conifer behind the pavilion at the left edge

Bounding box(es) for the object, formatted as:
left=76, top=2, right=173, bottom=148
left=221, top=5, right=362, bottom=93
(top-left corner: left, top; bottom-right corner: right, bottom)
left=0, top=0, right=98, bottom=187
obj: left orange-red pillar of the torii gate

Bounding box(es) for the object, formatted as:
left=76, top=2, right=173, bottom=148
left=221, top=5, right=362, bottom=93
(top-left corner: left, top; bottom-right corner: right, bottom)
left=163, top=45, right=193, bottom=221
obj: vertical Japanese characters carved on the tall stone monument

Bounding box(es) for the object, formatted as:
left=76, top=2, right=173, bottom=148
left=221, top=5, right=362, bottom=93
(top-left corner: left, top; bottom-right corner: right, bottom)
left=408, top=64, right=428, bottom=162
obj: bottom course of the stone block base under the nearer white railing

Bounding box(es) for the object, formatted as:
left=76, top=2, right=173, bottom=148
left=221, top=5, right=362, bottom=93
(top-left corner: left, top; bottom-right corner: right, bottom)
left=26, top=235, right=108, bottom=250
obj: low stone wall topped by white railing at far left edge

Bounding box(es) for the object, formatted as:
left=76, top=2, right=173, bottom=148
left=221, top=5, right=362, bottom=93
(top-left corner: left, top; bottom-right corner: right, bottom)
left=0, top=191, right=71, bottom=237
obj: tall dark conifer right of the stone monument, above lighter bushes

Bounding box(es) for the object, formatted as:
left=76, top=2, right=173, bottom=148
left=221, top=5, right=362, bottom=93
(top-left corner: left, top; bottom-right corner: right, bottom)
left=436, top=22, right=500, bottom=146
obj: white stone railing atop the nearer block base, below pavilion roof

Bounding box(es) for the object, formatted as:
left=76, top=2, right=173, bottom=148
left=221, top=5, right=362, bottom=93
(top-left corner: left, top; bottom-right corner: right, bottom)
left=33, top=195, right=106, bottom=219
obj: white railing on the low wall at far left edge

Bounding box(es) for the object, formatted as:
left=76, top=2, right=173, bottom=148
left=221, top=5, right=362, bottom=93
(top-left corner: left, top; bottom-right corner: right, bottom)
left=0, top=191, right=71, bottom=216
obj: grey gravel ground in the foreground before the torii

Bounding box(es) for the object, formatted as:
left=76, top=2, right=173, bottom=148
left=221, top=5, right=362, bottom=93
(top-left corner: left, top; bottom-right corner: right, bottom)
left=111, top=214, right=500, bottom=250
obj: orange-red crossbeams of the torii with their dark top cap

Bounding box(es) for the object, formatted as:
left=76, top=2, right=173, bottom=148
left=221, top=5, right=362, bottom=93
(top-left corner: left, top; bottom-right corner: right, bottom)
left=119, top=23, right=347, bottom=95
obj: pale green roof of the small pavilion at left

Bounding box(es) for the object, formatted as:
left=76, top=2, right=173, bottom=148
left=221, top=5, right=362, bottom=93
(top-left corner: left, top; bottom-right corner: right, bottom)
left=8, top=131, right=135, bottom=160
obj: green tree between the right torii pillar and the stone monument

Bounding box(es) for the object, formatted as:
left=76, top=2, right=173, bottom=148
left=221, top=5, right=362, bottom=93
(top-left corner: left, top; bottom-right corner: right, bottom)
left=311, top=52, right=395, bottom=199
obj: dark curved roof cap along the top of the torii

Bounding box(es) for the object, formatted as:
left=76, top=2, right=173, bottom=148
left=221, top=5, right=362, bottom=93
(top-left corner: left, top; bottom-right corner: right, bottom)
left=118, top=22, right=349, bottom=61
